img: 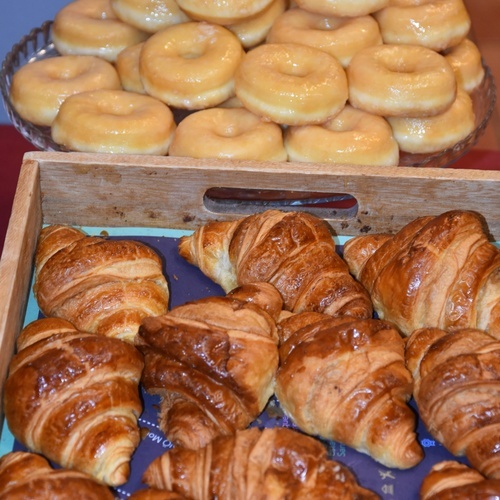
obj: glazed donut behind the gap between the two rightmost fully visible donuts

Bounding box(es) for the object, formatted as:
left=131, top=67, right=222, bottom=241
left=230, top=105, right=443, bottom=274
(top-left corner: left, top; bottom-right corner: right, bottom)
left=267, top=8, right=382, bottom=68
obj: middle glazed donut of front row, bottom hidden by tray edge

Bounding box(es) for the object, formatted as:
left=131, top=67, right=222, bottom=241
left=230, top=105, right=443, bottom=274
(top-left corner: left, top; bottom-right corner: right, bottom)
left=169, top=108, right=287, bottom=161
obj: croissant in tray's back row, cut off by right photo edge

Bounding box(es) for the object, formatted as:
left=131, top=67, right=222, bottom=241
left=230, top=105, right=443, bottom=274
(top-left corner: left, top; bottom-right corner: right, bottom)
left=344, top=210, right=500, bottom=339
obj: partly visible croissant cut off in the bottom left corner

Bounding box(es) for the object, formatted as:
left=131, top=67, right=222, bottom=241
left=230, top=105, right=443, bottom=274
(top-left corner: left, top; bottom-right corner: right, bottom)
left=0, top=451, right=114, bottom=500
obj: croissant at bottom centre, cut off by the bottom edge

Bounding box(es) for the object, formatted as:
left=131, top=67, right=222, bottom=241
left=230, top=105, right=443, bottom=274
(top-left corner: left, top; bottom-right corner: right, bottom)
left=143, top=427, right=378, bottom=500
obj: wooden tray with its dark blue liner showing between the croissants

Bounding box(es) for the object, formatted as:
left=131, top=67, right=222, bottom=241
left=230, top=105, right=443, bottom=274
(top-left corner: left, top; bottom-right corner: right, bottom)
left=0, top=152, right=500, bottom=500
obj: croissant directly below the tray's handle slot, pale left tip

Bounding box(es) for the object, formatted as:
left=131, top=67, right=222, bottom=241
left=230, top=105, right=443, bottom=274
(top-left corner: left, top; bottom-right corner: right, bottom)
left=179, top=210, right=372, bottom=318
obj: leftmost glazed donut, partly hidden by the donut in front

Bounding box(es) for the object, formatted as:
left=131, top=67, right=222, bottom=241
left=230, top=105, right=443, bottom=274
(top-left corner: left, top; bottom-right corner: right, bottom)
left=10, top=56, right=121, bottom=127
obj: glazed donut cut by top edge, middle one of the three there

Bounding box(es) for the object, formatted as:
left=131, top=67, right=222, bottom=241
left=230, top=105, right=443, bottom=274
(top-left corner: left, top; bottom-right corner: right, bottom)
left=177, top=0, right=273, bottom=25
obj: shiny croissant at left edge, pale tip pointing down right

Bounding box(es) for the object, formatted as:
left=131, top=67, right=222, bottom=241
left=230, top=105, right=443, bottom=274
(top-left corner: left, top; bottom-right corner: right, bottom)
left=4, top=318, right=144, bottom=486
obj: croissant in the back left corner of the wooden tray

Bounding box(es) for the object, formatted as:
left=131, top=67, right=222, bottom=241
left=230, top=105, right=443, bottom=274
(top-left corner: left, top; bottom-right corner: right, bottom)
left=34, top=225, right=169, bottom=342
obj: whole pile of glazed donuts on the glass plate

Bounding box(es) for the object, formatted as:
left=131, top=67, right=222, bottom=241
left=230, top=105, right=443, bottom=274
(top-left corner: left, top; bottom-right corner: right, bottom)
left=7, top=0, right=484, bottom=166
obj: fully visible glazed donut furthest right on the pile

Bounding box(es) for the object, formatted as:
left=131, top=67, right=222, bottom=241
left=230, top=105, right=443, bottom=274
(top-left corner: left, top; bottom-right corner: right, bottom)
left=347, top=44, right=457, bottom=117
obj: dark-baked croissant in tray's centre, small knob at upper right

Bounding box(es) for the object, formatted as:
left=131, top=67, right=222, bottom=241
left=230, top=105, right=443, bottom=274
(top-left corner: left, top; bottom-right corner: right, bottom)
left=136, top=283, right=282, bottom=448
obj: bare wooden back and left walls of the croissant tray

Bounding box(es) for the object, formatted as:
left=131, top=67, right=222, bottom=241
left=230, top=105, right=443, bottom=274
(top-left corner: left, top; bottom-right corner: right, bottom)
left=0, top=152, right=500, bottom=432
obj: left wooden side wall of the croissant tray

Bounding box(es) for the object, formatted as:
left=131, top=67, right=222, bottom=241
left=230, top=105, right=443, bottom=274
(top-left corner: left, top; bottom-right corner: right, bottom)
left=0, top=160, right=42, bottom=428
